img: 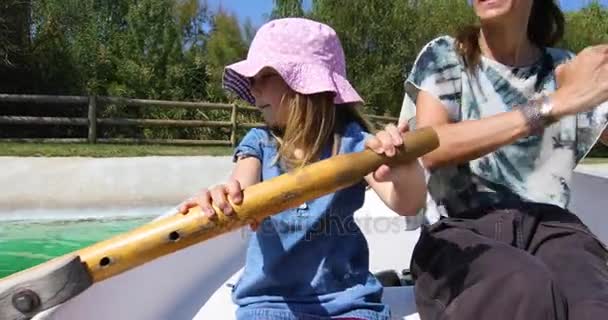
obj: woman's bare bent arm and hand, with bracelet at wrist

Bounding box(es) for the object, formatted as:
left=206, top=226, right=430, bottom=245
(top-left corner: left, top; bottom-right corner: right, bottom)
left=416, top=45, right=608, bottom=169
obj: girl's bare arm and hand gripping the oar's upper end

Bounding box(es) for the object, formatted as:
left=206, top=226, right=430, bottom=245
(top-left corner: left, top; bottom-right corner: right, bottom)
left=365, top=123, right=426, bottom=216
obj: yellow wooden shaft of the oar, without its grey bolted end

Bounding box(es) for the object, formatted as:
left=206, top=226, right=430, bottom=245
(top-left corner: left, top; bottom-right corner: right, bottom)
left=0, top=128, right=439, bottom=318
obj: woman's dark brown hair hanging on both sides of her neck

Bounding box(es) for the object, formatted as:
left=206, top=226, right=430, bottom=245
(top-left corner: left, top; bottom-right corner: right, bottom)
left=456, top=0, right=565, bottom=70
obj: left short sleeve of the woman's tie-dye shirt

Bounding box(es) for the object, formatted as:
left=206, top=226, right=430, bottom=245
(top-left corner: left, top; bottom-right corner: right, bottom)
left=401, top=36, right=463, bottom=120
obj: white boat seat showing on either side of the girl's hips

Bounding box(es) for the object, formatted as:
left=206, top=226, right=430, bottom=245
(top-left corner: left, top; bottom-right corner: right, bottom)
left=193, top=269, right=420, bottom=320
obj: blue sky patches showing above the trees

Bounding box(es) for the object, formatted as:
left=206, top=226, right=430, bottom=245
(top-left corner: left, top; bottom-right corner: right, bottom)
left=207, top=0, right=608, bottom=26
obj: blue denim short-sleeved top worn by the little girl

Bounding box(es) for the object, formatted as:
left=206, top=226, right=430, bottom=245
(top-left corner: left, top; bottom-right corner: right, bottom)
left=228, top=122, right=389, bottom=320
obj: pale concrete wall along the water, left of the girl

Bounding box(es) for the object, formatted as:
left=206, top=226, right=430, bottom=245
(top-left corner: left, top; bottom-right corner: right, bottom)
left=0, top=156, right=233, bottom=211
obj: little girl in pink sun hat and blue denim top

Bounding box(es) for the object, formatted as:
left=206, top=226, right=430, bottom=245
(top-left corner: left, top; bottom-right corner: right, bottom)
left=180, top=18, right=426, bottom=320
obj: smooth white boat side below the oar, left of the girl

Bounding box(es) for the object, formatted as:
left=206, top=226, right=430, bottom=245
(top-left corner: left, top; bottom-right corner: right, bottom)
left=36, top=226, right=247, bottom=320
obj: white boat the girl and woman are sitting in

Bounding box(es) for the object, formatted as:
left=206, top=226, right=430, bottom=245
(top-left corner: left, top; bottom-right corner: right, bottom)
left=36, top=173, right=608, bottom=320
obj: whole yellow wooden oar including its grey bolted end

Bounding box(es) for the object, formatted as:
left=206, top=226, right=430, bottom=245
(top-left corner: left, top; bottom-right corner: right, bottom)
left=0, top=128, right=439, bottom=320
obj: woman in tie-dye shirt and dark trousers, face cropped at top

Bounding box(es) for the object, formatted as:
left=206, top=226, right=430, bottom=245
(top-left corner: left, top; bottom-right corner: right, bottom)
left=400, top=0, right=608, bottom=319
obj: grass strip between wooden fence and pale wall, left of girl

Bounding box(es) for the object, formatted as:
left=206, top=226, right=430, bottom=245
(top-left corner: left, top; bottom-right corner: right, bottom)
left=0, top=142, right=232, bottom=158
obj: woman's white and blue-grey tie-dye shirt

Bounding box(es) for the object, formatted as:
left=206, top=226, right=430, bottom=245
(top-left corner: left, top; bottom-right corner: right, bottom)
left=402, top=36, right=608, bottom=215
